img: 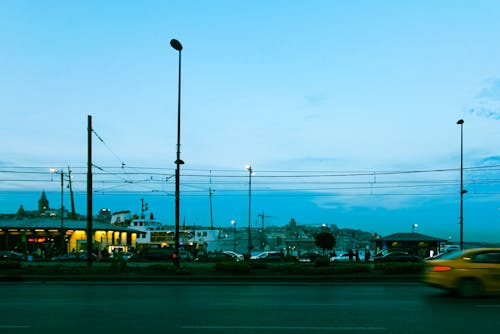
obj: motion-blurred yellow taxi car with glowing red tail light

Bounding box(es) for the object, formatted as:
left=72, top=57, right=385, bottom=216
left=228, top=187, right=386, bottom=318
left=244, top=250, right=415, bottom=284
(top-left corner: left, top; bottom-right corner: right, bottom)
left=423, top=248, right=500, bottom=297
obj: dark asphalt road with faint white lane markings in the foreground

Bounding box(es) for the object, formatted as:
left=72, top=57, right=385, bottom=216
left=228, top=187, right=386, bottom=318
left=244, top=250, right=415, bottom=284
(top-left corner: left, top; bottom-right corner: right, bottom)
left=0, top=282, right=500, bottom=334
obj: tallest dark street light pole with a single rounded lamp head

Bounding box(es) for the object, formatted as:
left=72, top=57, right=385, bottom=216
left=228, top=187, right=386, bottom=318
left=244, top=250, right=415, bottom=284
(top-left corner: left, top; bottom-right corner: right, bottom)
left=170, top=39, right=184, bottom=266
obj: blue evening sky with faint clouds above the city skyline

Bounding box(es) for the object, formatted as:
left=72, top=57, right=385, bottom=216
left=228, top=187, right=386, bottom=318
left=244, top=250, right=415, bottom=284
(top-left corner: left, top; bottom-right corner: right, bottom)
left=0, top=0, right=500, bottom=241
